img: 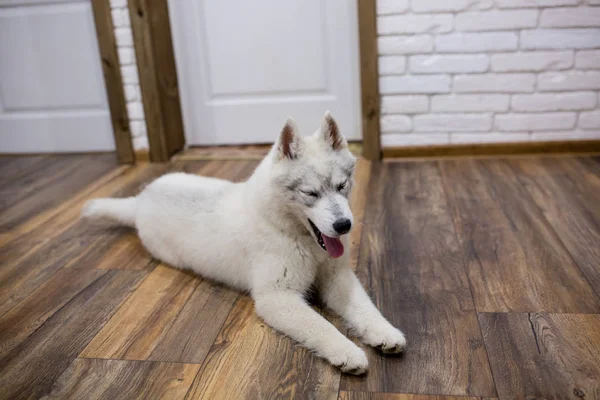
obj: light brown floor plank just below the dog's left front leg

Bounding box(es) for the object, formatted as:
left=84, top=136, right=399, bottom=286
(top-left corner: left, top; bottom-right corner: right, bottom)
left=188, top=296, right=339, bottom=399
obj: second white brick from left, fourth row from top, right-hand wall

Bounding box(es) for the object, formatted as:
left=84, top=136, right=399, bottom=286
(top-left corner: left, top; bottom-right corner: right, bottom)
left=410, top=54, right=490, bottom=74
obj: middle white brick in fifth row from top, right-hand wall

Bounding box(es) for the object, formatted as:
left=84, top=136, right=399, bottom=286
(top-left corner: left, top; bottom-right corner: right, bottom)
left=453, top=74, right=535, bottom=93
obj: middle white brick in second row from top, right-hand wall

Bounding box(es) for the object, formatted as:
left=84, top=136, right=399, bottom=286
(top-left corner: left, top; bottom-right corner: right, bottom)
left=454, top=10, right=538, bottom=32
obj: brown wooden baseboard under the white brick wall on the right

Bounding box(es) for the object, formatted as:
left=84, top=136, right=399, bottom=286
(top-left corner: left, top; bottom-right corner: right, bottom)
left=382, top=140, right=600, bottom=158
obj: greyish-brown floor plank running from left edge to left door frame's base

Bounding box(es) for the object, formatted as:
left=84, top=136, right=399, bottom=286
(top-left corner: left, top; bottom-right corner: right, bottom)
left=0, top=154, right=116, bottom=233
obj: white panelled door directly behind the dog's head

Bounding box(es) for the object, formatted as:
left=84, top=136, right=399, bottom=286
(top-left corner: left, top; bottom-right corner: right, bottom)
left=169, top=0, right=361, bottom=145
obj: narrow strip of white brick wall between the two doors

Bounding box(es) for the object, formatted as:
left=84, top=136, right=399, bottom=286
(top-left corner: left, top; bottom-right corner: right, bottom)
left=110, top=0, right=148, bottom=150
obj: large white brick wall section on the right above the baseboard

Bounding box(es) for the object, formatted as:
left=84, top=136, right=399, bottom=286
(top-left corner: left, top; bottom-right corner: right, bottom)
left=377, top=0, right=600, bottom=146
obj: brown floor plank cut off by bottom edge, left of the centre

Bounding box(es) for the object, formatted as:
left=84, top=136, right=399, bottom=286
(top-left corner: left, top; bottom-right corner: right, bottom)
left=46, top=358, right=200, bottom=399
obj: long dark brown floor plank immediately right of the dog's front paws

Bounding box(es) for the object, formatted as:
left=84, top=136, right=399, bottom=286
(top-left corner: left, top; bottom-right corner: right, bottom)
left=340, top=162, right=495, bottom=396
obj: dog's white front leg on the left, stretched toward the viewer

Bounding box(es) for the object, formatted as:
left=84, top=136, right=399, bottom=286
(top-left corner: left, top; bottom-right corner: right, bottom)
left=254, top=290, right=368, bottom=375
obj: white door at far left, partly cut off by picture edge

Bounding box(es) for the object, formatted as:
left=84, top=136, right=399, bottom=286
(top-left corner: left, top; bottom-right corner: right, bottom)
left=0, top=0, right=115, bottom=153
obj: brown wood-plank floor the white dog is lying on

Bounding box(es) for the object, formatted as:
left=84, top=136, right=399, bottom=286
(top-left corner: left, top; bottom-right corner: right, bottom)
left=0, top=155, right=600, bottom=400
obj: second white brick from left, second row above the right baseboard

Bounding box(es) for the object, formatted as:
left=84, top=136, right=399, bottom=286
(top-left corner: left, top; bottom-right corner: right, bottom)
left=413, top=114, right=492, bottom=132
